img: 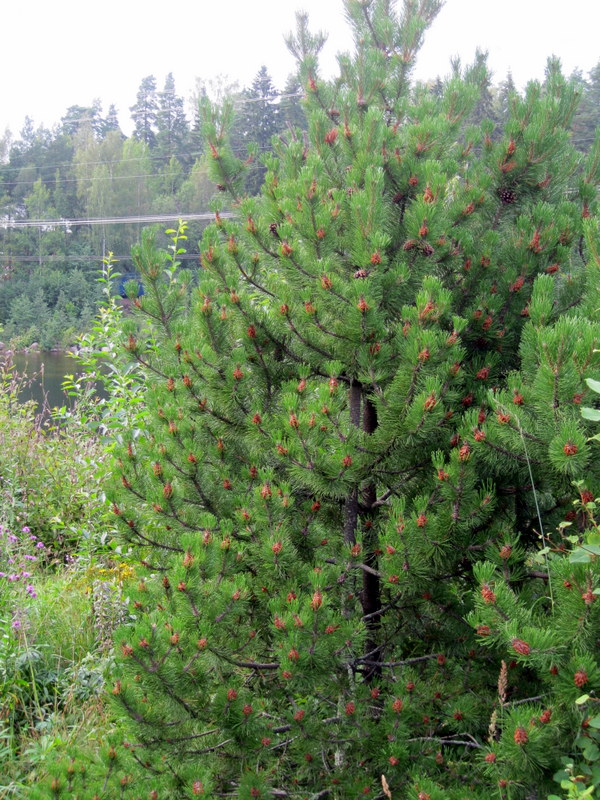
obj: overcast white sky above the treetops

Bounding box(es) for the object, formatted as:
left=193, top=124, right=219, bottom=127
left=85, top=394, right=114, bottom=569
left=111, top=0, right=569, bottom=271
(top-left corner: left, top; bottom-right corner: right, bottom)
left=0, top=0, right=600, bottom=135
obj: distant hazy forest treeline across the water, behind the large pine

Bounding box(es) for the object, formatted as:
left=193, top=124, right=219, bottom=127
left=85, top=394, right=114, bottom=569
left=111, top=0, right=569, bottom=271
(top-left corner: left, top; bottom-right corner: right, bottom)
left=0, top=60, right=600, bottom=348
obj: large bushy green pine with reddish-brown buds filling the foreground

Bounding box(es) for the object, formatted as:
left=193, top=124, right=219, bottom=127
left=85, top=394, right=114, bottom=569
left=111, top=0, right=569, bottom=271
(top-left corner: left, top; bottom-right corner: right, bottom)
left=55, top=0, right=600, bottom=800
